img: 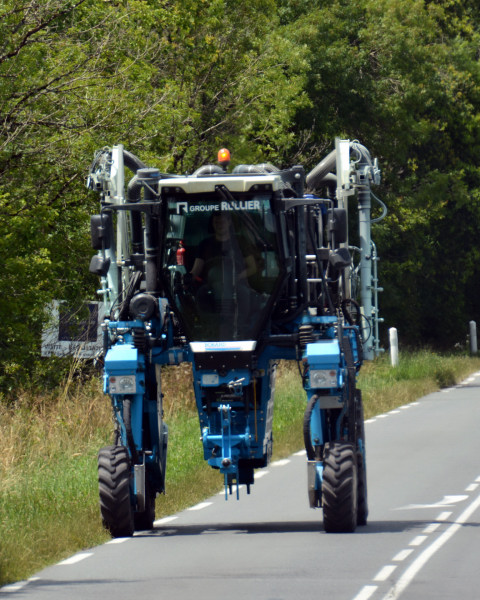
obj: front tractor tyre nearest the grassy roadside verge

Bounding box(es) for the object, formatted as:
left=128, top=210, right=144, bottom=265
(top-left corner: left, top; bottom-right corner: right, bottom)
left=98, top=446, right=134, bottom=537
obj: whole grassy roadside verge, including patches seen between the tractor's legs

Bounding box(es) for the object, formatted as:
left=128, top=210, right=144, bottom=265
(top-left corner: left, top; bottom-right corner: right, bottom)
left=0, top=352, right=480, bottom=585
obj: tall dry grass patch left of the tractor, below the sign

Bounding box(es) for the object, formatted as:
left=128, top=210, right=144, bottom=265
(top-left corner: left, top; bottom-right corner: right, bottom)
left=0, top=380, right=112, bottom=583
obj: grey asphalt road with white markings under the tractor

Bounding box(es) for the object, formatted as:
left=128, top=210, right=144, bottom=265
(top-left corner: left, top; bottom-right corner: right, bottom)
left=0, top=373, right=480, bottom=600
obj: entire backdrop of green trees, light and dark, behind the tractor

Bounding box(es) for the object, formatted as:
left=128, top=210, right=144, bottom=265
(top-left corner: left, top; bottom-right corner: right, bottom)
left=0, top=0, right=480, bottom=393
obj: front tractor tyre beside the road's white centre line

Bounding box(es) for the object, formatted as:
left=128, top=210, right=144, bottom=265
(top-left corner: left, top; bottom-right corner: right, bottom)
left=322, top=442, right=358, bottom=533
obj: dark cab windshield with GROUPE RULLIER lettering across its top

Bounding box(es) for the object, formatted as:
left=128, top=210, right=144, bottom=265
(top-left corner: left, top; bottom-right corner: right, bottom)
left=163, top=190, right=280, bottom=341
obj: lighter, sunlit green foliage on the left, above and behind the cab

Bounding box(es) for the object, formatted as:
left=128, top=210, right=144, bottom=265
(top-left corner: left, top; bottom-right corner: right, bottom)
left=0, top=0, right=306, bottom=394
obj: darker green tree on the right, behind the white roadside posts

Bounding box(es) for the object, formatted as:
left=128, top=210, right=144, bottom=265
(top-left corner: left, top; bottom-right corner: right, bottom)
left=282, top=0, right=480, bottom=346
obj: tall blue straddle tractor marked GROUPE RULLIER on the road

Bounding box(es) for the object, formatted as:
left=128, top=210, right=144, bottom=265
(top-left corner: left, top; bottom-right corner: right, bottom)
left=87, top=140, right=379, bottom=537
